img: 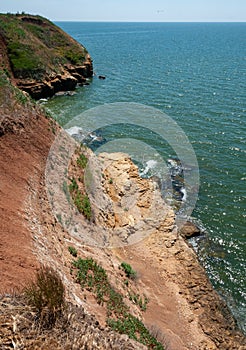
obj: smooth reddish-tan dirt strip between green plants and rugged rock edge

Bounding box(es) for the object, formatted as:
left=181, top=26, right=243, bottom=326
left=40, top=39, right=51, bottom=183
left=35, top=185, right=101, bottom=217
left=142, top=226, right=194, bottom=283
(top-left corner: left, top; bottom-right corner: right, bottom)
left=114, top=228, right=212, bottom=350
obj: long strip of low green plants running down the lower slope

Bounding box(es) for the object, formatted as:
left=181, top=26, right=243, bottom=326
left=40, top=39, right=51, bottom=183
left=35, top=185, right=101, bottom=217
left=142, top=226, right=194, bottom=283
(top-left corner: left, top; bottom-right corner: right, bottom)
left=71, top=257, right=164, bottom=350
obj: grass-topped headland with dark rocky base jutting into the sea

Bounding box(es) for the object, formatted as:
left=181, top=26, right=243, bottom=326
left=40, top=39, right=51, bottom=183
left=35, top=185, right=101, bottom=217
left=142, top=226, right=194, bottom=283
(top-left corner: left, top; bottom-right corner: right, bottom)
left=0, top=15, right=93, bottom=99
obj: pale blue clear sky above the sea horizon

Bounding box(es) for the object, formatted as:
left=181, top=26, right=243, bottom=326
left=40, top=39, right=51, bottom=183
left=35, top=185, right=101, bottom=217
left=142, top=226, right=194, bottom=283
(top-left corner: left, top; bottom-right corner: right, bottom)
left=0, top=0, right=246, bottom=22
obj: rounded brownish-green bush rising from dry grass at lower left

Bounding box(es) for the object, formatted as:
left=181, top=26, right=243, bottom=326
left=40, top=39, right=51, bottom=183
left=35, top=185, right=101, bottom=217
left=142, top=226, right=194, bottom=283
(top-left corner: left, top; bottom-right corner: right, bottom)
left=24, top=267, right=65, bottom=328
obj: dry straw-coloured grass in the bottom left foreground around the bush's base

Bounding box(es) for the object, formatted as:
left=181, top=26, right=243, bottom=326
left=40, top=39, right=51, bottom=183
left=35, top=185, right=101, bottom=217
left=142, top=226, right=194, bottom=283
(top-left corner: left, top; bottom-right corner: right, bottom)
left=0, top=294, right=144, bottom=350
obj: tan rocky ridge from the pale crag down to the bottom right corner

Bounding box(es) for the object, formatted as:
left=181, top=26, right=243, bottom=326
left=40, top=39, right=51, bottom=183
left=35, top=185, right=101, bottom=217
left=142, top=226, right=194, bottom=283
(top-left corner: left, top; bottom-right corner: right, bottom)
left=66, top=148, right=245, bottom=350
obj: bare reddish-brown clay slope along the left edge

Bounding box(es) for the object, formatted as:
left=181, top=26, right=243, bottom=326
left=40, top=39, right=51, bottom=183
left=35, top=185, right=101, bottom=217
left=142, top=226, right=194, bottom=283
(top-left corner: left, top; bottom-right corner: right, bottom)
left=0, top=108, right=54, bottom=292
